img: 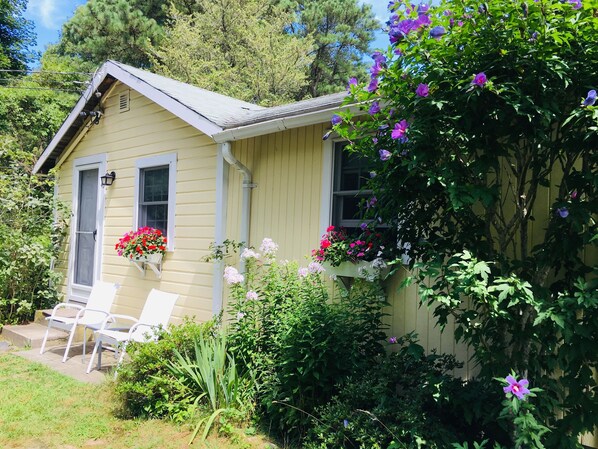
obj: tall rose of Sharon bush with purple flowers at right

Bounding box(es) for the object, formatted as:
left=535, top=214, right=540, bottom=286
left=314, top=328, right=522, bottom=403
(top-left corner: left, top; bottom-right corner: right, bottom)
left=335, top=0, right=598, bottom=448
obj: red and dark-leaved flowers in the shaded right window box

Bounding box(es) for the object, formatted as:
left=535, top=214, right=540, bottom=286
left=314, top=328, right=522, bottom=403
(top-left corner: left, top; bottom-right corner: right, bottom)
left=312, top=223, right=392, bottom=267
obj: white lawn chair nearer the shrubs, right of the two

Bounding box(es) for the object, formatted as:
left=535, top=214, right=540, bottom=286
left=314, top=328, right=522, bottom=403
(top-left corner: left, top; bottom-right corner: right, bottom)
left=87, top=288, right=179, bottom=376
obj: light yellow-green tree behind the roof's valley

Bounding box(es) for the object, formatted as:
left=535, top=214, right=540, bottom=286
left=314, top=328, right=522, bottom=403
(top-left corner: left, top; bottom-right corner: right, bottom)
left=152, top=0, right=312, bottom=105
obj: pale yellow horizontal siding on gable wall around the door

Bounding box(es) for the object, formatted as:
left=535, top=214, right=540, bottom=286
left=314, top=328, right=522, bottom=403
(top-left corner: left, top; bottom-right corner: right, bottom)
left=58, top=83, right=217, bottom=322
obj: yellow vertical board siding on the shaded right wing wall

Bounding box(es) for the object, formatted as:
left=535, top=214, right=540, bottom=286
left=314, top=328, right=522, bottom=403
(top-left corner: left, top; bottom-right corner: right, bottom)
left=226, top=125, right=472, bottom=375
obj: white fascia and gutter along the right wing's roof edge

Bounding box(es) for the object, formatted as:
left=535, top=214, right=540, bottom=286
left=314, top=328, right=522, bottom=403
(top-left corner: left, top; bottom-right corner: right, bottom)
left=212, top=105, right=365, bottom=143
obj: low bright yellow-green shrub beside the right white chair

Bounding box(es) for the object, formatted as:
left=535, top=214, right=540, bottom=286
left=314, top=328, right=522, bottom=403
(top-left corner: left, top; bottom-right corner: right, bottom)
left=115, top=319, right=215, bottom=421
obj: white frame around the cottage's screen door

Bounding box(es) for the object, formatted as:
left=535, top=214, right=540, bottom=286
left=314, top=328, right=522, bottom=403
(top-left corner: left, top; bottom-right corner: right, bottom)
left=67, top=153, right=106, bottom=304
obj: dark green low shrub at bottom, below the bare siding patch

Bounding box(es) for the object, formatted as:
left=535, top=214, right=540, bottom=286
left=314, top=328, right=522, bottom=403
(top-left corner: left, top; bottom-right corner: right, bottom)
left=305, top=334, right=501, bottom=449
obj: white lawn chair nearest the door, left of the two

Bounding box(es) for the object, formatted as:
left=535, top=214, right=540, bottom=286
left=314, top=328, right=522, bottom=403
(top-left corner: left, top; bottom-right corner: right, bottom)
left=39, top=281, right=118, bottom=363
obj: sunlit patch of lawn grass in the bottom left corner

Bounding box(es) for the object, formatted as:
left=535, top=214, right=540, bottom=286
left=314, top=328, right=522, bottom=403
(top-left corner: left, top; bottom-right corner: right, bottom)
left=0, top=354, right=270, bottom=449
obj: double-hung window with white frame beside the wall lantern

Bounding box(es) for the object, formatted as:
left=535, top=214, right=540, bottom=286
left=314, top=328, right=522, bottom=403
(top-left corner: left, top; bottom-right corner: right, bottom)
left=135, top=154, right=176, bottom=250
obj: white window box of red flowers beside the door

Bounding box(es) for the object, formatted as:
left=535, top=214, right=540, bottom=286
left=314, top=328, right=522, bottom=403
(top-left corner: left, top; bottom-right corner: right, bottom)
left=114, top=226, right=167, bottom=277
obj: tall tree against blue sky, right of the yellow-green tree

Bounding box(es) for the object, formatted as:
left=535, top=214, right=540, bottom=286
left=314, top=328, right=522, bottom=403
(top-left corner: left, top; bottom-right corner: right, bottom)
left=279, top=0, right=380, bottom=99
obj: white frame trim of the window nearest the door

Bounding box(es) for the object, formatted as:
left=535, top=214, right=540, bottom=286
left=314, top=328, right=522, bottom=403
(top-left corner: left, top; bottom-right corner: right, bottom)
left=133, top=153, right=177, bottom=251
